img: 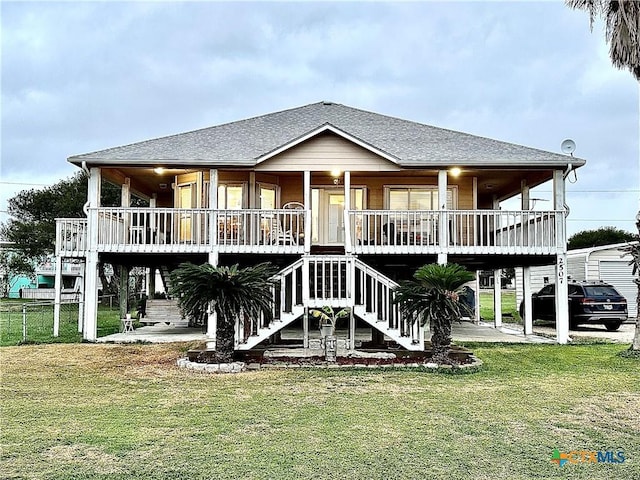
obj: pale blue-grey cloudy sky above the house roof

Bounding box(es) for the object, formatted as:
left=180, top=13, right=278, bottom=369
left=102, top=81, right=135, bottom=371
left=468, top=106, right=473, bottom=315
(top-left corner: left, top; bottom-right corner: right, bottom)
left=0, top=1, right=640, bottom=234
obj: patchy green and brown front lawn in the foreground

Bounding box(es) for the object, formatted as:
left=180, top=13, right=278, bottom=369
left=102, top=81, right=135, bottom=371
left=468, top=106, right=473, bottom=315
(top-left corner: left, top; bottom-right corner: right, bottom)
left=0, top=344, right=640, bottom=480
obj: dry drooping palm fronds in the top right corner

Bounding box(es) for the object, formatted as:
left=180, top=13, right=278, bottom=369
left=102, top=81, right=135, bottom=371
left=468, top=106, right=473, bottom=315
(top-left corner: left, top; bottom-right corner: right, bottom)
left=566, top=0, right=640, bottom=80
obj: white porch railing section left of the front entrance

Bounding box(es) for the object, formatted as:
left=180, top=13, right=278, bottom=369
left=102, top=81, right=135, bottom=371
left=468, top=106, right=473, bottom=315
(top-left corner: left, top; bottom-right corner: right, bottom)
left=71, top=207, right=305, bottom=253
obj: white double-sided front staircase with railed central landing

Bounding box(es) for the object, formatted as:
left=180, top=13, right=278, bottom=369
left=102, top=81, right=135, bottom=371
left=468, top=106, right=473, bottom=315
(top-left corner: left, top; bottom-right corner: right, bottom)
left=236, top=255, right=424, bottom=350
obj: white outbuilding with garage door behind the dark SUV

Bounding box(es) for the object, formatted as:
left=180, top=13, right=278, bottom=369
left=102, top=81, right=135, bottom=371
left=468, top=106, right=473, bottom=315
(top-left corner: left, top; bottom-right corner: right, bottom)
left=516, top=243, right=638, bottom=318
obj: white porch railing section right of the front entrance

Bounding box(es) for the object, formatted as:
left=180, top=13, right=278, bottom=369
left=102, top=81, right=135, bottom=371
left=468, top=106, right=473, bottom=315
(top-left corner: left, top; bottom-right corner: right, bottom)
left=347, top=210, right=565, bottom=254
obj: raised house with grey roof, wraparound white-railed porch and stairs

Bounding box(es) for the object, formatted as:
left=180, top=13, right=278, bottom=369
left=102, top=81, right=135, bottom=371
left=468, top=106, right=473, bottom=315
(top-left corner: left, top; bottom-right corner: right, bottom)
left=56, top=102, right=585, bottom=350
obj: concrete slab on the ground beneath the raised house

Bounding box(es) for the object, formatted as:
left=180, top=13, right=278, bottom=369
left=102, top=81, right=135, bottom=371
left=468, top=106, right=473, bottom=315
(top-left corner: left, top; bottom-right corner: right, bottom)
left=97, top=322, right=554, bottom=343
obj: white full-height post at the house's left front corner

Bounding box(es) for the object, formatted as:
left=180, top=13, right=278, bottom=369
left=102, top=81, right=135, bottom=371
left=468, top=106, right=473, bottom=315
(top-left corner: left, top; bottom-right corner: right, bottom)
left=83, top=167, right=102, bottom=342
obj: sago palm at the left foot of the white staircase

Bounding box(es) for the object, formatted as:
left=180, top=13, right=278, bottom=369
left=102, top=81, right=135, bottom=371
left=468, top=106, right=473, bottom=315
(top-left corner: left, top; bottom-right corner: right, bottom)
left=171, top=263, right=277, bottom=363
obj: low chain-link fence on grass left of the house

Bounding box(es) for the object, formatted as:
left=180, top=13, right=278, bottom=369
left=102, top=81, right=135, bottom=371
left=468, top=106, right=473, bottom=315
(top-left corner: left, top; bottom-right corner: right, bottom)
left=0, top=298, right=120, bottom=346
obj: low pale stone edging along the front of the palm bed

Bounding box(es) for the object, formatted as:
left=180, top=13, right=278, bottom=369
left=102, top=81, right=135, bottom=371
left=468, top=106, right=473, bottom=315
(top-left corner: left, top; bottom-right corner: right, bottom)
left=177, top=355, right=483, bottom=373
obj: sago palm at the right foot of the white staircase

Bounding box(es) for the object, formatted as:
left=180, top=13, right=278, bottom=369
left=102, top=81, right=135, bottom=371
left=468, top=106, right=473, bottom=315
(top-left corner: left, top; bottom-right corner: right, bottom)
left=395, top=263, right=475, bottom=364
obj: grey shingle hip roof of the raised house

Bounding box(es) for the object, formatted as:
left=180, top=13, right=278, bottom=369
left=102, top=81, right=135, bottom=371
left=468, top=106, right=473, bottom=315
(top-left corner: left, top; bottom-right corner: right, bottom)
left=69, top=102, right=585, bottom=167
